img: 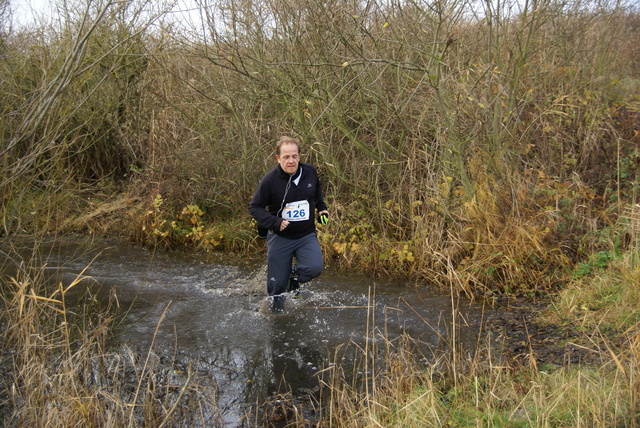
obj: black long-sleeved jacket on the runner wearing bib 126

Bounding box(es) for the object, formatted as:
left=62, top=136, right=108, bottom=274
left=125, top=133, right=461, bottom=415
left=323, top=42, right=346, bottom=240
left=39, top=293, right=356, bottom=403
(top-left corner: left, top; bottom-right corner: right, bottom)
left=249, top=162, right=327, bottom=239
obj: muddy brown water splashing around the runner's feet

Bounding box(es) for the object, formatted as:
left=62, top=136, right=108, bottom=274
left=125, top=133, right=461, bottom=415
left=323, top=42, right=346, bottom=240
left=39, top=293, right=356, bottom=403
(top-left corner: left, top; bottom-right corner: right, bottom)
left=0, top=241, right=479, bottom=426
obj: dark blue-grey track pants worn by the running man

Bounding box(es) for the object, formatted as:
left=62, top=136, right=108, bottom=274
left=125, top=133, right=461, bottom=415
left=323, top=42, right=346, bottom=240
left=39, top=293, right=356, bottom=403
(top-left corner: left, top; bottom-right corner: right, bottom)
left=267, top=231, right=322, bottom=296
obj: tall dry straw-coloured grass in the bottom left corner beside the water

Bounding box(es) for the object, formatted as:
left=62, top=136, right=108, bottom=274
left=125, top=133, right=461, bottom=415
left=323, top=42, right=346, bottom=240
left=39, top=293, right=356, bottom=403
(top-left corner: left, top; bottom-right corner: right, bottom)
left=0, top=246, right=221, bottom=427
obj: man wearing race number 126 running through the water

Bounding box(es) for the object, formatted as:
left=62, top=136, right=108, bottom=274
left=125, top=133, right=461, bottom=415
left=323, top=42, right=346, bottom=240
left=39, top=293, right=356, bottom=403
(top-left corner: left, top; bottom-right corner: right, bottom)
left=249, top=136, right=329, bottom=312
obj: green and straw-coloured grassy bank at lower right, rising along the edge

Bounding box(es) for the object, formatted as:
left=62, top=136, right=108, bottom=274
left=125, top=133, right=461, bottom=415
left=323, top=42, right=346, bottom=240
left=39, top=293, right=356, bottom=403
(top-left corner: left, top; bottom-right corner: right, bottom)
left=312, top=246, right=640, bottom=427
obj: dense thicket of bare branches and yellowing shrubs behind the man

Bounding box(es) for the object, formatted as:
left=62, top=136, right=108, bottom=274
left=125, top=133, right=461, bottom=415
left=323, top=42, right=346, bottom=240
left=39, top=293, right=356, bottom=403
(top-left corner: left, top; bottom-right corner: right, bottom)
left=0, top=0, right=640, bottom=293
